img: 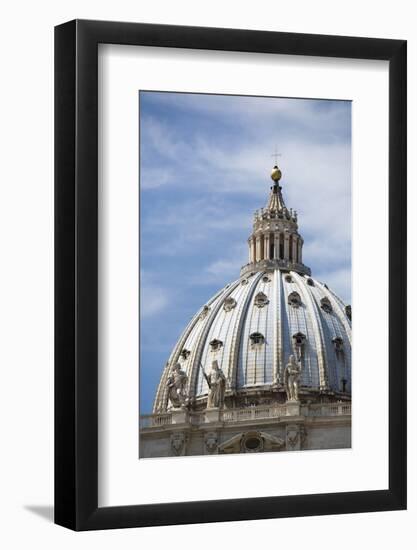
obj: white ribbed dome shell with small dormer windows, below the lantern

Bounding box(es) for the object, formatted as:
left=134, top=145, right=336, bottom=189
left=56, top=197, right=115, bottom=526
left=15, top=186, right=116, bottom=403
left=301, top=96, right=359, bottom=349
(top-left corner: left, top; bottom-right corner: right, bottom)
left=154, top=269, right=351, bottom=411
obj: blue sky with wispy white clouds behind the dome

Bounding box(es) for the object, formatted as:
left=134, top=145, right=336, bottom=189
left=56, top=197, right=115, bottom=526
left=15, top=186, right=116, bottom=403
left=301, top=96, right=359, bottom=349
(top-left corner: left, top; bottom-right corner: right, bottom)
left=139, top=92, right=351, bottom=413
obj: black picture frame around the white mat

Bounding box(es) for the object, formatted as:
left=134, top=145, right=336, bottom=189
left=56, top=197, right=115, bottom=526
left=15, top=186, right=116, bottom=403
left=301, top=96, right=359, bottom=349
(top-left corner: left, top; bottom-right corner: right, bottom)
left=55, top=20, right=407, bottom=531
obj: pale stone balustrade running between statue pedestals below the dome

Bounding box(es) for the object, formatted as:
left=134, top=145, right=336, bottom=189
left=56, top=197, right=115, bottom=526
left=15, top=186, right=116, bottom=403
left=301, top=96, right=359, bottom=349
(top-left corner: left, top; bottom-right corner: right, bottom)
left=140, top=403, right=352, bottom=428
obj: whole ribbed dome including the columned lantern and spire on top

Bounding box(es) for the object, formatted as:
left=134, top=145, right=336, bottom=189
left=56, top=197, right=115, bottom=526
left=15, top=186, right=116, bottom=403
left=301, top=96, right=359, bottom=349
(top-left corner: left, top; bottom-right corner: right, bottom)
left=154, top=166, right=351, bottom=413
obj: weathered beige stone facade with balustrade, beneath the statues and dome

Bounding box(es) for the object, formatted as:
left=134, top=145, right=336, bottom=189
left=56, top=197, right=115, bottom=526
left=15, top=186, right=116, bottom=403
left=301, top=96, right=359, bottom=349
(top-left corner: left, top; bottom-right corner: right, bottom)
left=139, top=402, right=351, bottom=458
